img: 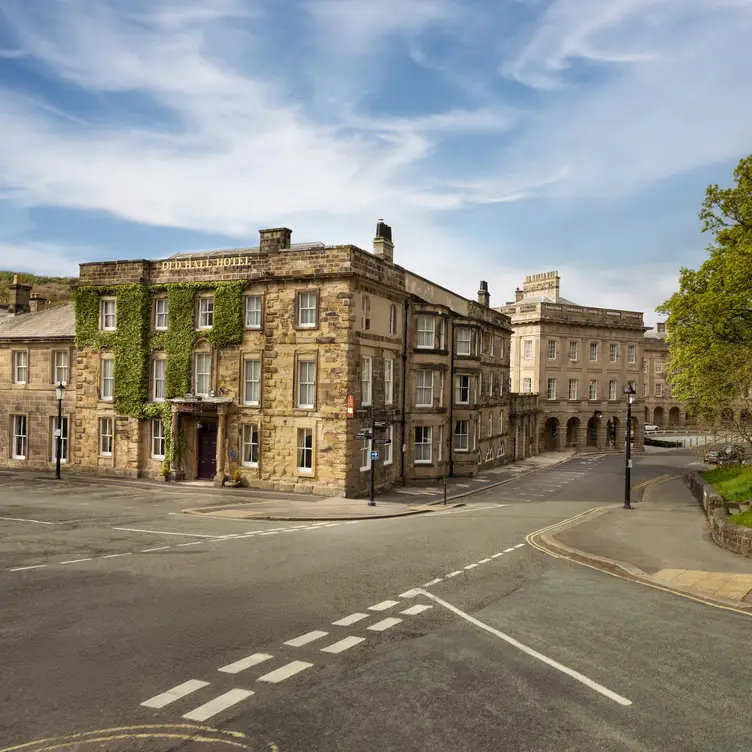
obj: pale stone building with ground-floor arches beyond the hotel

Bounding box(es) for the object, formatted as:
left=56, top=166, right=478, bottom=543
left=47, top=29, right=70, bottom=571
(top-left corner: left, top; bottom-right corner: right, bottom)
left=497, top=271, right=646, bottom=451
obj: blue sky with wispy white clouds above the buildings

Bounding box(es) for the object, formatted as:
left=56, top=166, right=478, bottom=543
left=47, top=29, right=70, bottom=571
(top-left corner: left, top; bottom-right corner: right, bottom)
left=0, top=0, right=752, bottom=325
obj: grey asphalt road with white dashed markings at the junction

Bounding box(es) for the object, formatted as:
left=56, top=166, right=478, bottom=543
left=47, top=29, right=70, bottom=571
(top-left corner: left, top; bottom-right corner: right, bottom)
left=0, top=453, right=750, bottom=752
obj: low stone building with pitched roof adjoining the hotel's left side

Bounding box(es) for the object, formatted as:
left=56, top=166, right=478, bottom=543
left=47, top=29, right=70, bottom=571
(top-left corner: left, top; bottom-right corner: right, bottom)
left=0, top=276, right=76, bottom=468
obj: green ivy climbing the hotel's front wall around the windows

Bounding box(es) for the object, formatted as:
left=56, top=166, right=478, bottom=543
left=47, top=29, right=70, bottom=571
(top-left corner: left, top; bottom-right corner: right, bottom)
left=74, top=280, right=247, bottom=468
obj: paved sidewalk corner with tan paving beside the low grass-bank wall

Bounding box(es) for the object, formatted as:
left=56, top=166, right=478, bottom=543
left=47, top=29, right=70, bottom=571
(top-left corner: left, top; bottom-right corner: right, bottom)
left=549, top=477, right=752, bottom=602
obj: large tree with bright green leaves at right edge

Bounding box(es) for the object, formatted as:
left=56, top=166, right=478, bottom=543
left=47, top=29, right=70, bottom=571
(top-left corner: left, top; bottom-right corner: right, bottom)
left=657, top=155, right=752, bottom=446
